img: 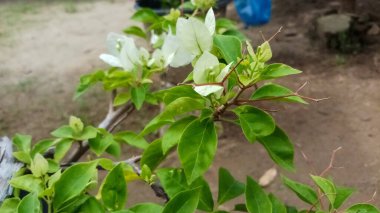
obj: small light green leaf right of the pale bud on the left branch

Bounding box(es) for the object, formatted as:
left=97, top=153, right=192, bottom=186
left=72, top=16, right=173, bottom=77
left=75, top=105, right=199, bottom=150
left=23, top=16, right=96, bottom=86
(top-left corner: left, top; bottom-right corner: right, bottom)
left=88, top=129, right=115, bottom=156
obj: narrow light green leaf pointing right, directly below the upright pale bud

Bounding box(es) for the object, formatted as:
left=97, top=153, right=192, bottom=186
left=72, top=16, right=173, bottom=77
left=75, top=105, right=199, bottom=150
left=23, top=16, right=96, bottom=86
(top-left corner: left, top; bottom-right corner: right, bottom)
left=260, top=64, right=301, bottom=80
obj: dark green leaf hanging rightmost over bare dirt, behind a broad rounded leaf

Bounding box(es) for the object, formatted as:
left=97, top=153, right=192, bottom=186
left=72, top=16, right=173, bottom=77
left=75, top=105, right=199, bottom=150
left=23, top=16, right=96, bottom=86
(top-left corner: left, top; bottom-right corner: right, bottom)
left=257, top=127, right=294, bottom=171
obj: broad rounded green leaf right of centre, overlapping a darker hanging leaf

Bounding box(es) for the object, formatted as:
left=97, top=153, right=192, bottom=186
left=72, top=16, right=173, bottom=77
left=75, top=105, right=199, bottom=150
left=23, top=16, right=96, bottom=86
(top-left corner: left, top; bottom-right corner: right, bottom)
left=233, top=106, right=276, bottom=143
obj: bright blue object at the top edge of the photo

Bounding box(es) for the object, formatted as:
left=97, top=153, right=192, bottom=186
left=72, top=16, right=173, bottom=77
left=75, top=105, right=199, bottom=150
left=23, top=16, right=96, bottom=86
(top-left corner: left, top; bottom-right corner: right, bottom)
left=235, top=0, right=272, bottom=26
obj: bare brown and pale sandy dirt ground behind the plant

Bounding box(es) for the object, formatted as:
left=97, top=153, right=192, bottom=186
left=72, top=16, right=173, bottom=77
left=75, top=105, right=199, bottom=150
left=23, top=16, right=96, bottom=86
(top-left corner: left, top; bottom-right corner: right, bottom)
left=0, top=0, right=380, bottom=210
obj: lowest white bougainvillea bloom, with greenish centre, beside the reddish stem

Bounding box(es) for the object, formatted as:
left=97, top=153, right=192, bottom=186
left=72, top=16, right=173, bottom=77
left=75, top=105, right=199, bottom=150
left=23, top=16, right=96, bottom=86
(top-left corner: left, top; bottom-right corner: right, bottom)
left=193, top=52, right=232, bottom=98
